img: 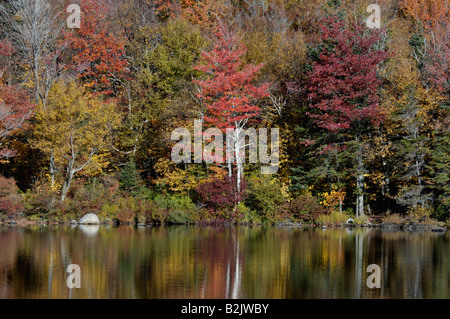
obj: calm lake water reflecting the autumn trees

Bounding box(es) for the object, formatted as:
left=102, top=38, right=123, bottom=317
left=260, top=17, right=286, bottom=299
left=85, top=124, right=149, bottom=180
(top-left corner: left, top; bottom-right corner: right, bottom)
left=0, top=226, right=450, bottom=299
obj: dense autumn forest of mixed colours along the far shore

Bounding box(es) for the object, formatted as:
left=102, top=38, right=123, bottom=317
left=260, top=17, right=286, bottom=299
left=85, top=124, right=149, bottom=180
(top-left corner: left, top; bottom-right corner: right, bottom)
left=0, top=0, right=450, bottom=225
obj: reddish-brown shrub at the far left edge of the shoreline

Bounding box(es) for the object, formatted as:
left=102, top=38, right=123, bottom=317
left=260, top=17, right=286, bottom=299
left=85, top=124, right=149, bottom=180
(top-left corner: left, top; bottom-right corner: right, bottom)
left=0, top=176, right=24, bottom=217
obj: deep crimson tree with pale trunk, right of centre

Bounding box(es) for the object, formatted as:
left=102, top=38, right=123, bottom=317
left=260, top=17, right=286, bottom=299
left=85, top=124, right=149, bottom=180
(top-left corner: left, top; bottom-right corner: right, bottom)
left=307, top=14, right=389, bottom=217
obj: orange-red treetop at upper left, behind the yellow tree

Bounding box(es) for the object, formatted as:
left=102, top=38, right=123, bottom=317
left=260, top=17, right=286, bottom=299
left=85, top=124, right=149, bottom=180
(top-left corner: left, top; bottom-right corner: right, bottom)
left=62, top=0, right=129, bottom=95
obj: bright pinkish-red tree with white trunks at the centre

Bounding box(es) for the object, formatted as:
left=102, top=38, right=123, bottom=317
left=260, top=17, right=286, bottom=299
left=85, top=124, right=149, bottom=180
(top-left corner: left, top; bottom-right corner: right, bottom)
left=194, top=21, right=269, bottom=208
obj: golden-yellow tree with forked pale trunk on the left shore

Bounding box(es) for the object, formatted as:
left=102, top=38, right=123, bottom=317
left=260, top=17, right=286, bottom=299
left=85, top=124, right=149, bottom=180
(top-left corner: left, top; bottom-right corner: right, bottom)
left=34, top=81, right=120, bottom=201
